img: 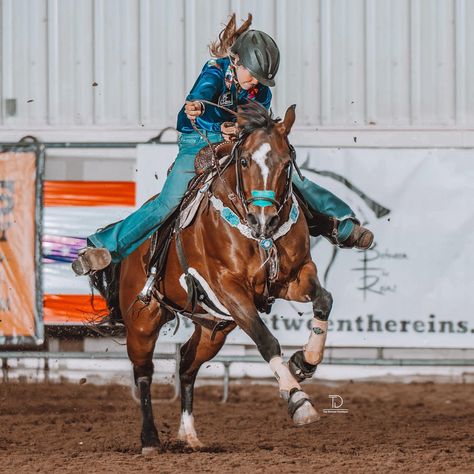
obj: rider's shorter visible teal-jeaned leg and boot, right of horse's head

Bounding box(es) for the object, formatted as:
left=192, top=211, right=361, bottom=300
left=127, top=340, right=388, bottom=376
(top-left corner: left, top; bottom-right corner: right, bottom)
left=293, top=173, right=373, bottom=248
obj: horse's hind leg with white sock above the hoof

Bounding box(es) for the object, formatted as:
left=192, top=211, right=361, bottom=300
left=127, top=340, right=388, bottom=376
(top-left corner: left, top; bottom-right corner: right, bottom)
left=178, top=322, right=236, bottom=449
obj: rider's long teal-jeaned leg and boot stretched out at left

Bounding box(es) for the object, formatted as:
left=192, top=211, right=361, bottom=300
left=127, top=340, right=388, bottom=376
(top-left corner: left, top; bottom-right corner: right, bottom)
left=73, top=132, right=222, bottom=273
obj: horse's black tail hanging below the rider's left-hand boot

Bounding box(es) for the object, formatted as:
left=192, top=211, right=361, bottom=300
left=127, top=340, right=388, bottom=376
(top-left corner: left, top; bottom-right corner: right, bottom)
left=89, top=262, right=123, bottom=323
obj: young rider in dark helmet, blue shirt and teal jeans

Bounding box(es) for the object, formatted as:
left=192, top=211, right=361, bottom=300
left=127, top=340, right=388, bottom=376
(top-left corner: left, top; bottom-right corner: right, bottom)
left=72, top=15, right=373, bottom=275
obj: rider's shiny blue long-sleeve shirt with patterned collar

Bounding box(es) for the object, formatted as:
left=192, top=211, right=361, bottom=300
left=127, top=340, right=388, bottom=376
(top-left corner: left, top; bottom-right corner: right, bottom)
left=176, top=58, right=272, bottom=133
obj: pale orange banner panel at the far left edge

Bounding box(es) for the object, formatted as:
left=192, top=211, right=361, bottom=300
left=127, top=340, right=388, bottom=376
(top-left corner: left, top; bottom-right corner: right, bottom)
left=0, top=152, right=40, bottom=344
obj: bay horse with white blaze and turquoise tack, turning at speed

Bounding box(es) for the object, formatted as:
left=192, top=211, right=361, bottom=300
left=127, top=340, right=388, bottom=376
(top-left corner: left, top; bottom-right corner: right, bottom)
left=90, top=103, right=332, bottom=454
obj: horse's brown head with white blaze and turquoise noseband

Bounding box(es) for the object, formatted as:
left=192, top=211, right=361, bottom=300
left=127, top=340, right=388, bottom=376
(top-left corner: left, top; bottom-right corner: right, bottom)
left=236, top=102, right=296, bottom=238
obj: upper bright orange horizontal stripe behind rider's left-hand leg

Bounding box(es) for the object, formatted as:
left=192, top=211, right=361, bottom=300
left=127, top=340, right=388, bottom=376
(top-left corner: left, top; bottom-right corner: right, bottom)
left=43, top=181, right=135, bottom=206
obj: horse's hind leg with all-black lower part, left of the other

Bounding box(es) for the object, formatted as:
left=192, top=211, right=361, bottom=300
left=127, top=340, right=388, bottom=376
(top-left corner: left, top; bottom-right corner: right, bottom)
left=125, top=301, right=172, bottom=454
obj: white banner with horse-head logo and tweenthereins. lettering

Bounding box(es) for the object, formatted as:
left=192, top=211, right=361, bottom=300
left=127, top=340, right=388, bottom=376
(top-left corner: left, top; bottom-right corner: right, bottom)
left=137, top=145, right=474, bottom=348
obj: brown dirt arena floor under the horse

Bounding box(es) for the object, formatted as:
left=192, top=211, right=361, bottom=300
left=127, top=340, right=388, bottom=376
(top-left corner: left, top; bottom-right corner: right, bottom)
left=0, top=380, right=474, bottom=474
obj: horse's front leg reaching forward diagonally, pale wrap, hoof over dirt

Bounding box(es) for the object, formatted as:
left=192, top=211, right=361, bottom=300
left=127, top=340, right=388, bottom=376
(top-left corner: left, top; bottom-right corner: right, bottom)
left=222, top=281, right=319, bottom=426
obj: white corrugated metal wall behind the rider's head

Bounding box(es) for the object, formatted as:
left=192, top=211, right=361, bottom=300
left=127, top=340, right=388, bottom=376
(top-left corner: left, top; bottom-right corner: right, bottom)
left=0, top=0, right=474, bottom=133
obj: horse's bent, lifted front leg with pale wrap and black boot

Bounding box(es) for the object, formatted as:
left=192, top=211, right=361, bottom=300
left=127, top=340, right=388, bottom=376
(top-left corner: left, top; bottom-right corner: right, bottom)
left=281, top=262, right=332, bottom=382
